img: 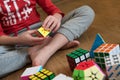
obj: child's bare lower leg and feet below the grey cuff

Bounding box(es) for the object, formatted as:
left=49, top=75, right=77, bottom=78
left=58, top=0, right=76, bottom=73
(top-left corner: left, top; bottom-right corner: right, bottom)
left=28, top=33, right=79, bottom=66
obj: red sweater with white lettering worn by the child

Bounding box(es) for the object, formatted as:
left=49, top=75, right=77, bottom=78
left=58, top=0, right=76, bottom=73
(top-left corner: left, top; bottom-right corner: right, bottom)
left=0, top=0, right=62, bottom=36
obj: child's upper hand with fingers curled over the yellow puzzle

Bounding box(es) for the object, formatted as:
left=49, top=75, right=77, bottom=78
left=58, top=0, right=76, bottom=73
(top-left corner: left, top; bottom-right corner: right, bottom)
left=42, top=13, right=62, bottom=32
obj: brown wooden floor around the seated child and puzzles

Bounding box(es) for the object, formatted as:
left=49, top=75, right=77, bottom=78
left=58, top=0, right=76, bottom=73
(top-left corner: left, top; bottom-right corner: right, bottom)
left=0, top=0, right=120, bottom=80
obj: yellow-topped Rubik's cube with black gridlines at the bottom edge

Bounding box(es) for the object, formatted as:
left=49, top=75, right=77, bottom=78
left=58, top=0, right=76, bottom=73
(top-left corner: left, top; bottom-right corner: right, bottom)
left=29, top=69, right=55, bottom=80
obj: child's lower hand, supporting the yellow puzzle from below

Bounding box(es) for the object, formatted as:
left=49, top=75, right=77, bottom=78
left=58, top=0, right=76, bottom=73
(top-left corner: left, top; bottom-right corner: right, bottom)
left=18, top=30, right=46, bottom=45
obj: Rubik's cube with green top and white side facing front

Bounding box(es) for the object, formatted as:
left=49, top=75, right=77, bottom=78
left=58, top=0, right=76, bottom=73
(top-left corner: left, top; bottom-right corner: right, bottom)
left=66, top=48, right=90, bottom=71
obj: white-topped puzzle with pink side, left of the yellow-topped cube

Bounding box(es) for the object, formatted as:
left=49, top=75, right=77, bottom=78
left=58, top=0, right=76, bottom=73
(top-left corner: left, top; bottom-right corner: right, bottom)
left=21, top=66, right=42, bottom=80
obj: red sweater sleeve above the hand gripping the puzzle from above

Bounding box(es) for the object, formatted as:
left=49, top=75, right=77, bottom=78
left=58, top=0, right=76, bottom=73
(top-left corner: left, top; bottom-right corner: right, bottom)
left=36, top=0, right=64, bottom=16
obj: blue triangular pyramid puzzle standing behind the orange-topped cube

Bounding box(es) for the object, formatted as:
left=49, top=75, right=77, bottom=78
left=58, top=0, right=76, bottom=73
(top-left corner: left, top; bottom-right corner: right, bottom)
left=90, top=33, right=105, bottom=58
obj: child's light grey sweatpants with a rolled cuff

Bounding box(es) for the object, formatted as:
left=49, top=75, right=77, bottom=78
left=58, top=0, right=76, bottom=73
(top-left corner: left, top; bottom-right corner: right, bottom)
left=0, top=6, right=95, bottom=77
